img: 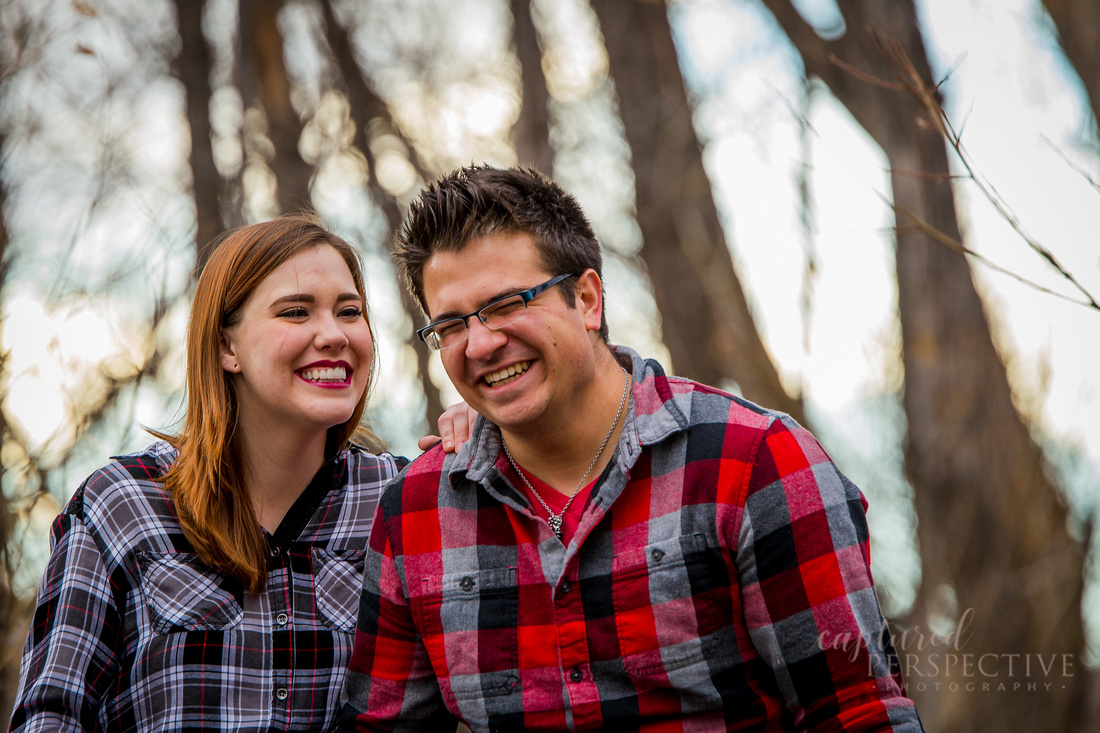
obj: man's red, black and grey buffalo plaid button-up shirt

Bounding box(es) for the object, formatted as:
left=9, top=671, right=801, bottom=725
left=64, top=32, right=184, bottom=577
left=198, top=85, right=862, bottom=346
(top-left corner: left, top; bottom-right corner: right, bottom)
left=342, top=348, right=921, bottom=732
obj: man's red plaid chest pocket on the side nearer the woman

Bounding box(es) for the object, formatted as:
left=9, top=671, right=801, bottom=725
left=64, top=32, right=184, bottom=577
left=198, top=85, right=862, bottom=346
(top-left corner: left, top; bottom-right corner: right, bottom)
left=422, top=568, right=519, bottom=711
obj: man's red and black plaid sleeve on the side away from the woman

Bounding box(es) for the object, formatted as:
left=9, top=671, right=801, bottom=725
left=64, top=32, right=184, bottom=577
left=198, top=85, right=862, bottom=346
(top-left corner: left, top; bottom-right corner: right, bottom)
left=737, top=418, right=923, bottom=732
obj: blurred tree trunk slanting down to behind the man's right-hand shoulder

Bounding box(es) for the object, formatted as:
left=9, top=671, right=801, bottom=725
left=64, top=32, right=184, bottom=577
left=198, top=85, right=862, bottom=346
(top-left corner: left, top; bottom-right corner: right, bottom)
left=592, top=0, right=806, bottom=424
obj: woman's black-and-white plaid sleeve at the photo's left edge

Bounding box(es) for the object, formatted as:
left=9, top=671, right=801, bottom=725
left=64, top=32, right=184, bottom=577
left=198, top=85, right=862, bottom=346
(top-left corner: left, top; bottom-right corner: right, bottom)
left=11, top=514, right=122, bottom=732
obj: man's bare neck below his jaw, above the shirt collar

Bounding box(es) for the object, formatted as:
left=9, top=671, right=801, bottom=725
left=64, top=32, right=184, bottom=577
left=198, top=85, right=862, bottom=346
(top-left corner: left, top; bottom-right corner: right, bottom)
left=503, top=351, right=630, bottom=496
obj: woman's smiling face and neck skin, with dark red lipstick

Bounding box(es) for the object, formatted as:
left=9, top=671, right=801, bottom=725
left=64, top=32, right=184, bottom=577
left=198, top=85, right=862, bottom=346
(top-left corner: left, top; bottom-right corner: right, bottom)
left=221, top=243, right=374, bottom=530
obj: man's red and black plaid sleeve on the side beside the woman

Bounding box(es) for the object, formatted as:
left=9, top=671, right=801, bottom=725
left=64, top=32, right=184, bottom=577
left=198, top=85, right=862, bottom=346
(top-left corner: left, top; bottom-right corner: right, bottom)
left=339, top=492, right=458, bottom=731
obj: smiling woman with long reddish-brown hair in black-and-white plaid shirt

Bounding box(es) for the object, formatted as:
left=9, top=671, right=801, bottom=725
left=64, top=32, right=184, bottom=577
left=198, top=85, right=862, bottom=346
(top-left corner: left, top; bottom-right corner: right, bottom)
left=6, top=217, right=461, bottom=731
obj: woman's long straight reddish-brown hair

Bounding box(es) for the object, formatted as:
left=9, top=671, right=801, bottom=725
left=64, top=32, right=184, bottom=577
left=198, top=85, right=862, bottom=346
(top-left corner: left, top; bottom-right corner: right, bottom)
left=157, top=215, right=376, bottom=592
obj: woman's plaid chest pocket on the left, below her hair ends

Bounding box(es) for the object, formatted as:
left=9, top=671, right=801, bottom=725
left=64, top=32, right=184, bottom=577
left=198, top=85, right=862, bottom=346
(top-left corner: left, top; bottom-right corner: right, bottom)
left=139, top=553, right=244, bottom=634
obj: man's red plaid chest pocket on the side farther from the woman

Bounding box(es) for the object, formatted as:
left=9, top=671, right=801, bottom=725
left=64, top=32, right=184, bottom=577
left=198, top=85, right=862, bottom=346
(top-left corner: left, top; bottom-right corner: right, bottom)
left=612, top=534, right=729, bottom=679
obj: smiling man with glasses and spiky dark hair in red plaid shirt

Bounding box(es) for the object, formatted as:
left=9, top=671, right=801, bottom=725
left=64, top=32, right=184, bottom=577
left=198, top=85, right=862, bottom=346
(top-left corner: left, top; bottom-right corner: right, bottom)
left=334, top=166, right=921, bottom=732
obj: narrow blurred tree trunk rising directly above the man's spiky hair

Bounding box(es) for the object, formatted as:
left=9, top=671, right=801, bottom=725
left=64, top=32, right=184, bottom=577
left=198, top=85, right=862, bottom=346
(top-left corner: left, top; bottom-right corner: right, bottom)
left=512, top=0, right=553, bottom=175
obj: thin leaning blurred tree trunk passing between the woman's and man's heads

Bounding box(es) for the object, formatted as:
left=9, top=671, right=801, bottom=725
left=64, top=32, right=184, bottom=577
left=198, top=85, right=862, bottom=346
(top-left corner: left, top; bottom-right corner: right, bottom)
left=321, top=0, right=443, bottom=431
